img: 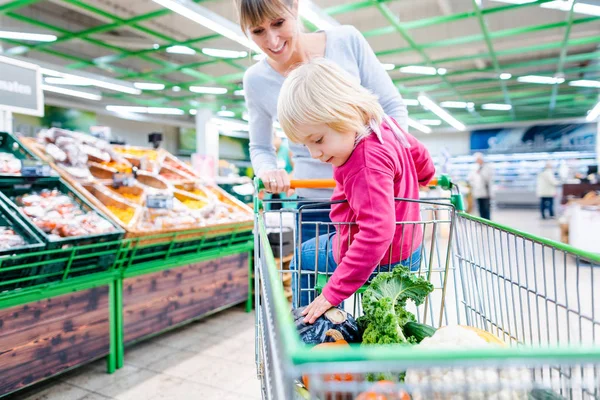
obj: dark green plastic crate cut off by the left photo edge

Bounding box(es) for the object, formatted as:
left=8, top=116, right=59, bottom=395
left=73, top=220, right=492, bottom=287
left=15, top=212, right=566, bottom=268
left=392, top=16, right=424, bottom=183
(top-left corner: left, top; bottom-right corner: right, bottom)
left=0, top=202, right=46, bottom=292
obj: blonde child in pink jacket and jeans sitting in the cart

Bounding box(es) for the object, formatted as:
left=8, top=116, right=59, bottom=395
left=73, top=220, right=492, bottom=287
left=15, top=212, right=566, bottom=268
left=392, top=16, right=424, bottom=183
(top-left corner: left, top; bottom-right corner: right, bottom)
left=278, top=58, right=435, bottom=324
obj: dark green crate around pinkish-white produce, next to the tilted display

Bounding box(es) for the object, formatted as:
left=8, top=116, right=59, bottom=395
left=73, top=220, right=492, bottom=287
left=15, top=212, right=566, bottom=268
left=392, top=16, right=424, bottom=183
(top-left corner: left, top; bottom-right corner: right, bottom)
left=0, top=180, right=124, bottom=285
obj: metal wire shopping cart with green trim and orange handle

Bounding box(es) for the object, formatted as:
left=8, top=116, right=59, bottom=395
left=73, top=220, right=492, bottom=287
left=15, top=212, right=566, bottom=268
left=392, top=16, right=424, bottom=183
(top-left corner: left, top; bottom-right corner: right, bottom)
left=255, top=179, right=600, bottom=400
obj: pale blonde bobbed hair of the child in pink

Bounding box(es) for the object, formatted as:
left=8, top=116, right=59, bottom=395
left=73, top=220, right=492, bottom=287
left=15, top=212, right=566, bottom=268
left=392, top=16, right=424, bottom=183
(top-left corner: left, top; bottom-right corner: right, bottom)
left=277, top=58, right=383, bottom=143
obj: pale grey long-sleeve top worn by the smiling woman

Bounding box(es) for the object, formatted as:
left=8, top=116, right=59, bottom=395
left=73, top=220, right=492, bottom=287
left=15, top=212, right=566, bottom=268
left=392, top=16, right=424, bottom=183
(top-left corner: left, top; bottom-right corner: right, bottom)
left=244, top=25, right=408, bottom=199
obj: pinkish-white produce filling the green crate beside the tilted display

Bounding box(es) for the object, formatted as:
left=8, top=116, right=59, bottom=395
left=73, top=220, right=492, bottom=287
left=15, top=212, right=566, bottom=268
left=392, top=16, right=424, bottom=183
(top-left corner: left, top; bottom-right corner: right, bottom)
left=14, top=189, right=115, bottom=240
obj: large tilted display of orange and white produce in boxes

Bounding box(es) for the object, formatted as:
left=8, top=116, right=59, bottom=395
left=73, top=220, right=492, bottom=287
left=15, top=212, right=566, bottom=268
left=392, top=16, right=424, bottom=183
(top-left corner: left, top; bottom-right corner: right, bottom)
left=19, top=128, right=252, bottom=236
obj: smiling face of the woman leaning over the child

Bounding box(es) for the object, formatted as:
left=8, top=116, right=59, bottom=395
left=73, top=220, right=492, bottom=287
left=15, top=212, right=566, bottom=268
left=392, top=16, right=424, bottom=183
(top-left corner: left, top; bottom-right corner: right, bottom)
left=250, top=6, right=298, bottom=64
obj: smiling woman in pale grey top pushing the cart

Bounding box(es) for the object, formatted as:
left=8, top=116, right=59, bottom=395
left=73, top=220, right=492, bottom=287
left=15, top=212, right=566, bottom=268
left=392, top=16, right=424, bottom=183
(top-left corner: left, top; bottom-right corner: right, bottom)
left=237, top=0, right=408, bottom=242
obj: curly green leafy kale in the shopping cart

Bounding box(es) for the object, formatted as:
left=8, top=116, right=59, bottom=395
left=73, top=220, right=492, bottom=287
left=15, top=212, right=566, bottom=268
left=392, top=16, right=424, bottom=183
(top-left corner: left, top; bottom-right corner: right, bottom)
left=358, top=266, right=433, bottom=344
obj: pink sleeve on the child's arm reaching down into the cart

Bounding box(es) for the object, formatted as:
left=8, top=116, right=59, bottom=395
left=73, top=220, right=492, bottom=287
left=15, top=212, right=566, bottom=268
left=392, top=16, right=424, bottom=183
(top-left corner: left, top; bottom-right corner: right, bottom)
left=323, top=167, right=396, bottom=305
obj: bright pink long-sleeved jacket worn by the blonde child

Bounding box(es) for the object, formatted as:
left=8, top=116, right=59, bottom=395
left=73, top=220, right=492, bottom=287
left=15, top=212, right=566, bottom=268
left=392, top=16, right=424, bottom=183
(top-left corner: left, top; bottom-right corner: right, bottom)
left=323, top=117, right=435, bottom=305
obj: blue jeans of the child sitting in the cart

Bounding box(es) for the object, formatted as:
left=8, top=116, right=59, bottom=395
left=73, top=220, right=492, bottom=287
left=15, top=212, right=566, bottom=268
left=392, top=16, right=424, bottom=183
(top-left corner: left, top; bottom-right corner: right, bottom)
left=290, top=232, right=421, bottom=307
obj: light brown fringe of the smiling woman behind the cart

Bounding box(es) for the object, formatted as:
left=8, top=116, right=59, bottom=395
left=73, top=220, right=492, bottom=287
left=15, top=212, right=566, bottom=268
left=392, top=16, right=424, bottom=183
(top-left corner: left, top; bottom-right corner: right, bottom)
left=236, top=0, right=294, bottom=35
